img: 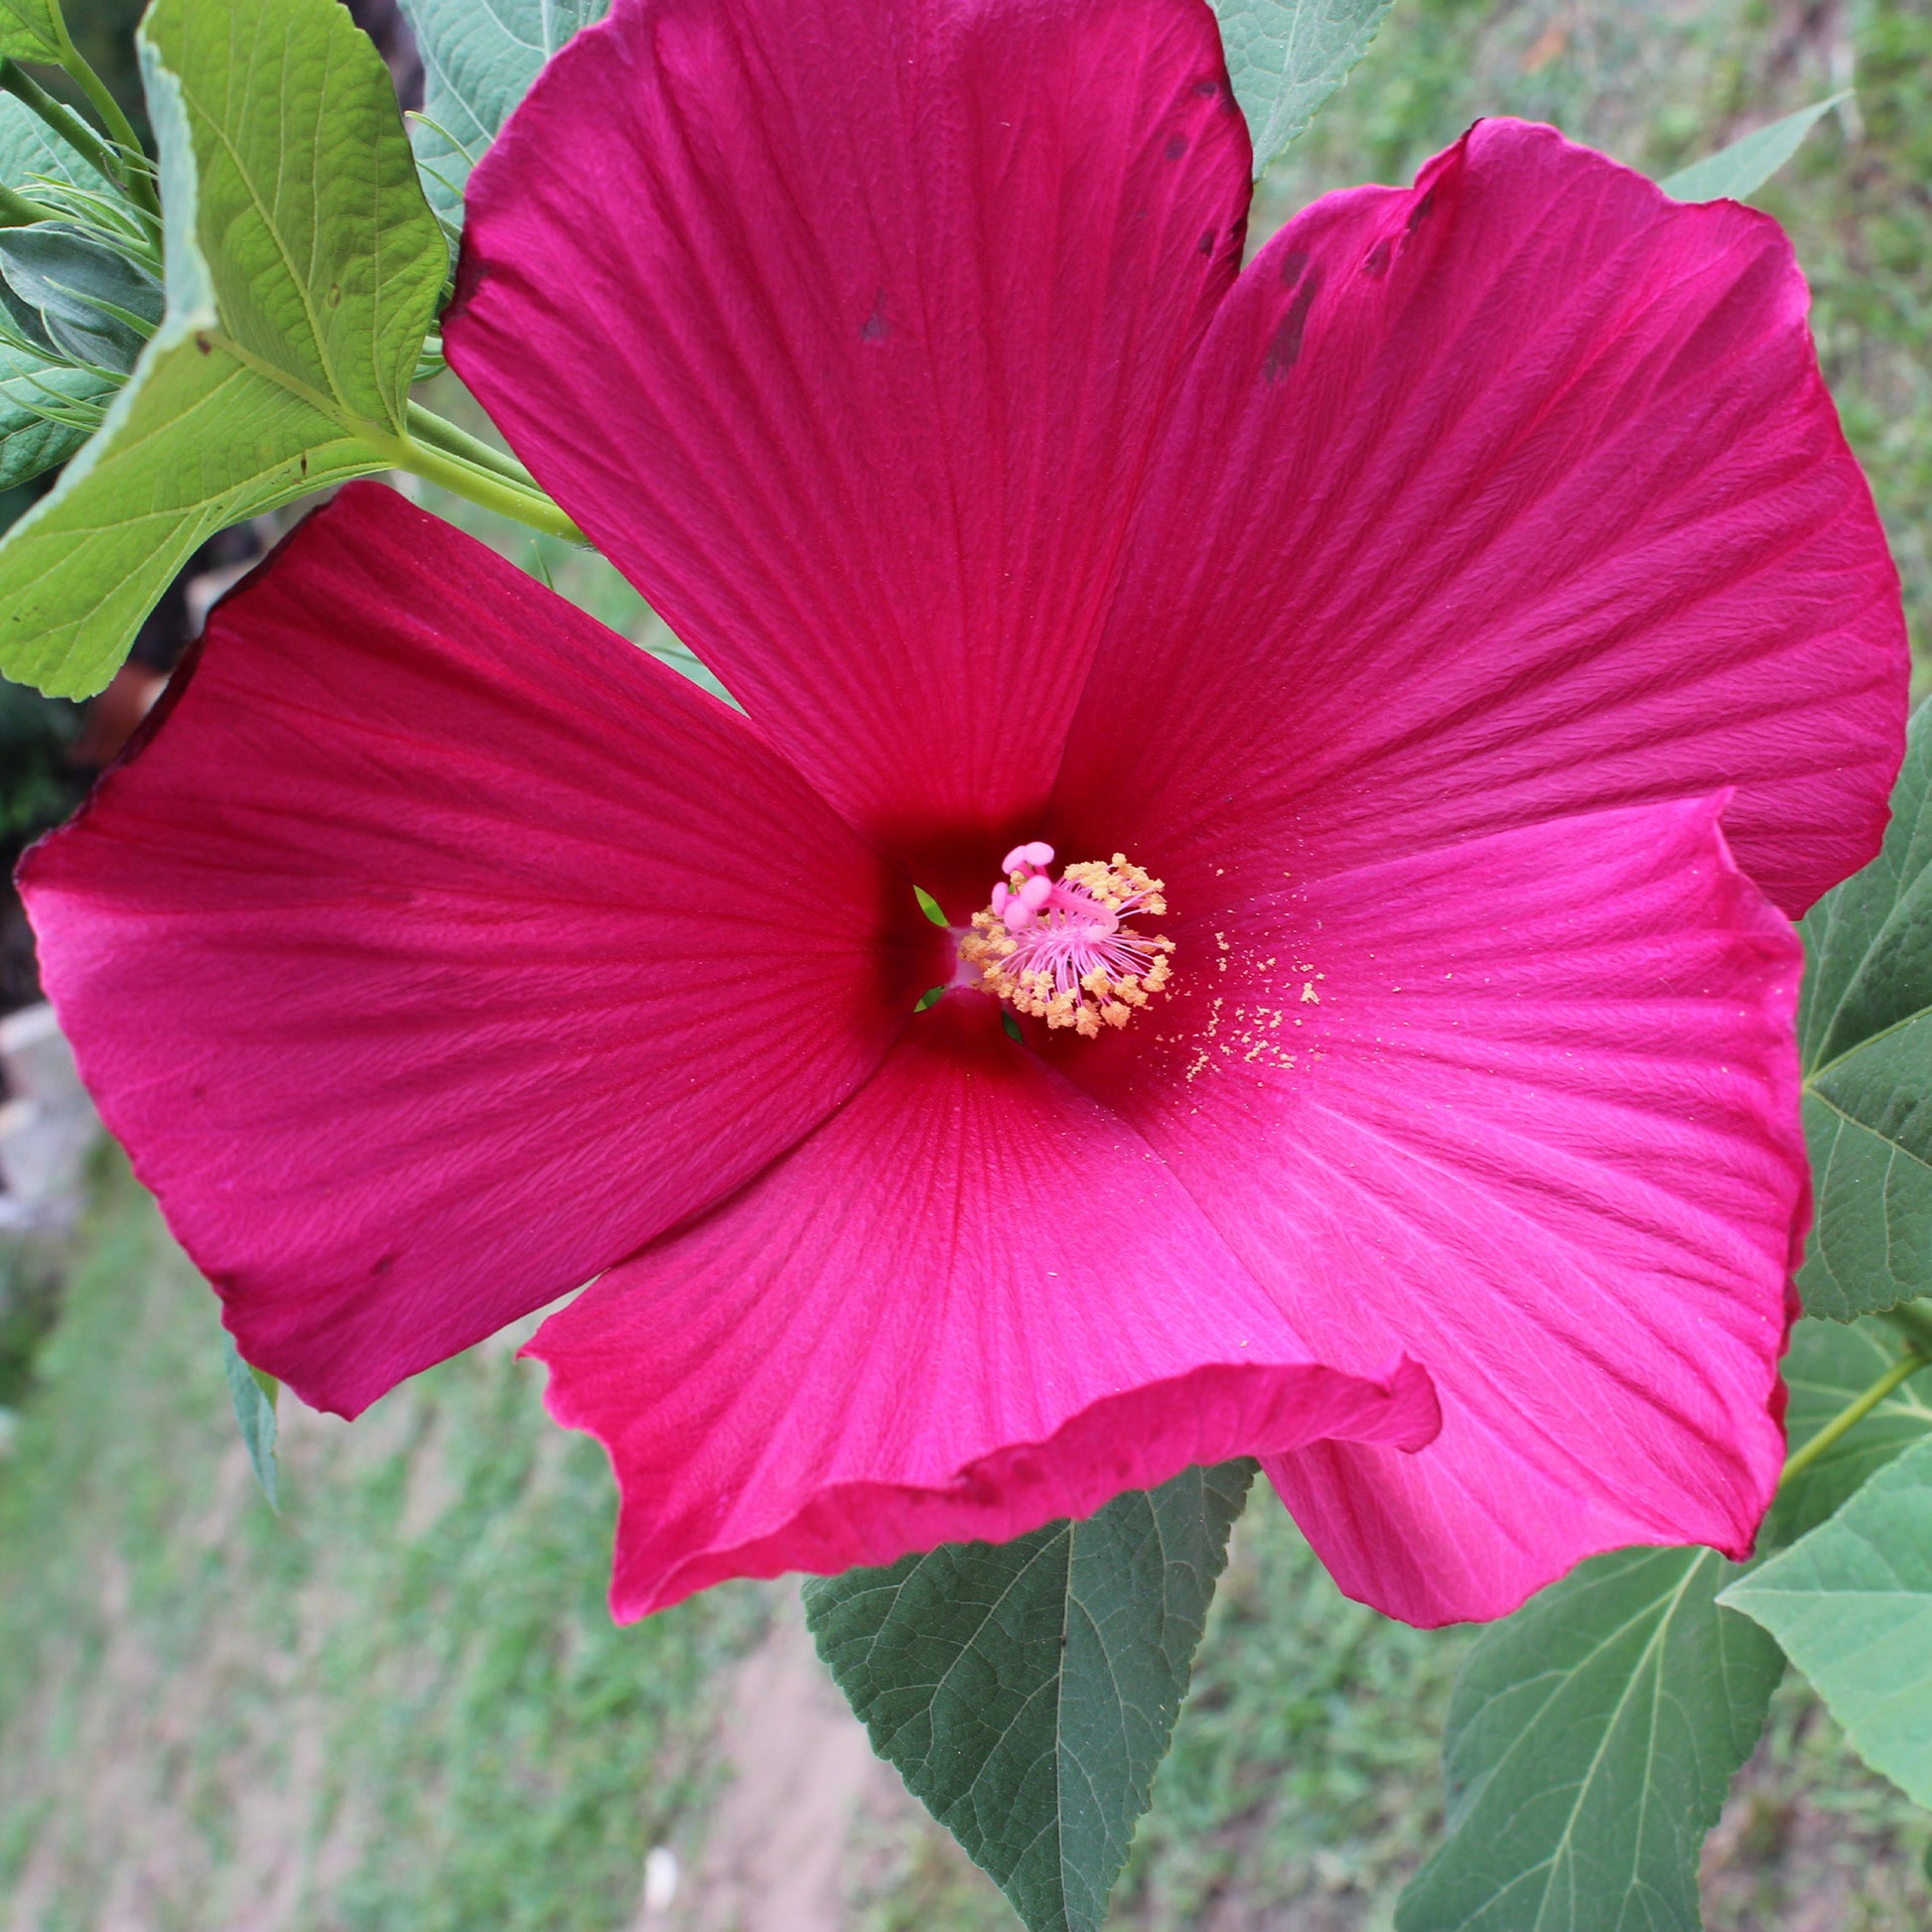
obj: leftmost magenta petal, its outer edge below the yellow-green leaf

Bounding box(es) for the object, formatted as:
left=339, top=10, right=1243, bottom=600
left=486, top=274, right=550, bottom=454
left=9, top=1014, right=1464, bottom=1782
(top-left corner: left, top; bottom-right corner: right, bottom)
left=23, top=484, right=917, bottom=1414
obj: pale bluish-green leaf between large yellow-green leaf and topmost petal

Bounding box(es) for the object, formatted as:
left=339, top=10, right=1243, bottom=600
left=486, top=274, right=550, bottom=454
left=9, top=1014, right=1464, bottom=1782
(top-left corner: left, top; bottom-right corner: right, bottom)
left=402, top=0, right=611, bottom=226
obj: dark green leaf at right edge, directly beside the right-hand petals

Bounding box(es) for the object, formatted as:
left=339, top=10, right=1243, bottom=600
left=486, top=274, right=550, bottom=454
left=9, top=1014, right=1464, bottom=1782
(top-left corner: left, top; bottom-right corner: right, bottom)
left=1799, top=711, right=1932, bottom=1321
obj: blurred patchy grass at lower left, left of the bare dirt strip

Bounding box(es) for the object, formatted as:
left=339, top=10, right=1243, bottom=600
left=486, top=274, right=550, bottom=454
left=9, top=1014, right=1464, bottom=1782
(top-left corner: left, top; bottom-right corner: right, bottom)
left=0, top=1154, right=769, bottom=1932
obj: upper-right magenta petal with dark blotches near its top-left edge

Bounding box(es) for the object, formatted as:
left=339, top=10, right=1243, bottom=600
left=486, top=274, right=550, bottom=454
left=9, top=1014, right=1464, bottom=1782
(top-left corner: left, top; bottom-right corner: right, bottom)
left=1058, top=122, right=1907, bottom=915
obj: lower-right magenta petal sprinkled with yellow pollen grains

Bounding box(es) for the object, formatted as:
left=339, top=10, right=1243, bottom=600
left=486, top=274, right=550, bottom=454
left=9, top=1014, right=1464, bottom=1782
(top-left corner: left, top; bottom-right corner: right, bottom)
left=1064, top=798, right=1807, bottom=1623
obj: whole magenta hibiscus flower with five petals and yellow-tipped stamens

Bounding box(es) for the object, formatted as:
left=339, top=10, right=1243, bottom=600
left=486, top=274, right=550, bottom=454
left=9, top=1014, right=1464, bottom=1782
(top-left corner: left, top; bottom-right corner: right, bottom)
left=25, top=0, right=1905, bottom=1621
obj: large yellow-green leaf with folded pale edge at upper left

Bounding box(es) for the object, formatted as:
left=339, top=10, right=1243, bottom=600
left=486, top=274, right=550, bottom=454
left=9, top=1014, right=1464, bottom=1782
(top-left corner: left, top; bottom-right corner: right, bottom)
left=0, top=0, right=447, bottom=698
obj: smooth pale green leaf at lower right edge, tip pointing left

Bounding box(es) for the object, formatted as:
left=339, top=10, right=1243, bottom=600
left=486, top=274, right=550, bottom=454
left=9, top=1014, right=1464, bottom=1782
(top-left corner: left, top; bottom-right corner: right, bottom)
left=1724, top=1442, right=1932, bottom=1805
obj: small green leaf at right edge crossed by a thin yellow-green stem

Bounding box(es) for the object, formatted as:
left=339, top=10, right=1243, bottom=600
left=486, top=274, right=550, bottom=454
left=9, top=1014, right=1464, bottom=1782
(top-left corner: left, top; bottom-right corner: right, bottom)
left=1760, top=1317, right=1932, bottom=1548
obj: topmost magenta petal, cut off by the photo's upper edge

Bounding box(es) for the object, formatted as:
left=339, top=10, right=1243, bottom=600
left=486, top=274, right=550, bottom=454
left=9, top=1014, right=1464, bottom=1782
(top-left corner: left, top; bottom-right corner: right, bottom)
left=448, top=0, right=1248, bottom=850
